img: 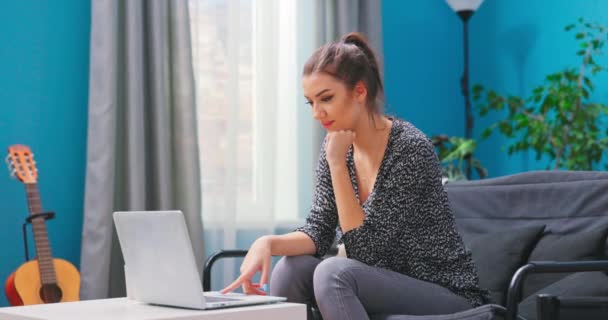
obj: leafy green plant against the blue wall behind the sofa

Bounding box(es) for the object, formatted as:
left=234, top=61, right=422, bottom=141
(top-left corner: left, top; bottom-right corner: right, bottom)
left=473, top=18, right=608, bottom=170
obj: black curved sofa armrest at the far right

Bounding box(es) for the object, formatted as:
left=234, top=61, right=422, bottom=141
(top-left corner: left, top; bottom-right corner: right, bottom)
left=505, top=260, right=608, bottom=320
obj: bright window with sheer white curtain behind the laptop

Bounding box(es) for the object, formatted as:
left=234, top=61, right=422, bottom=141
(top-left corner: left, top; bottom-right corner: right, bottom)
left=190, top=0, right=319, bottom=231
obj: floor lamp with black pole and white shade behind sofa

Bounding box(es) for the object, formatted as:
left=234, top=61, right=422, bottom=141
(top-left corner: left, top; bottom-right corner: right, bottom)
left=446, top=0, right=483, bottom=179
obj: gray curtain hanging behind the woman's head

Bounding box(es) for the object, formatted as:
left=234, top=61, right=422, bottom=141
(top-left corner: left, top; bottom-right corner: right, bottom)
left=313, top=0, right=383, bottom=170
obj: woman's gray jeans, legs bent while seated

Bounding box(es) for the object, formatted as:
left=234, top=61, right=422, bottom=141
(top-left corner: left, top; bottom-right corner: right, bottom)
left=270, top=256, right=471, bottom=320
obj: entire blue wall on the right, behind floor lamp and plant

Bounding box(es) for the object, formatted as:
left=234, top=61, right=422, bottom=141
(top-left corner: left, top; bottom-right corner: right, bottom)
left=383, top=0, right=608, bottom=176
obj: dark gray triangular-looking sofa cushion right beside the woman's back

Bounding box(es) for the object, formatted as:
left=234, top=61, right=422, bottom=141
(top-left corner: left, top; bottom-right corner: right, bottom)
left=463, top=225, right=545, bottom=305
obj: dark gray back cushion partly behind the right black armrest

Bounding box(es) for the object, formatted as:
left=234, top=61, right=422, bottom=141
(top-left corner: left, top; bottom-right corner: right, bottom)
left=523, top=224, right=608, bottom=298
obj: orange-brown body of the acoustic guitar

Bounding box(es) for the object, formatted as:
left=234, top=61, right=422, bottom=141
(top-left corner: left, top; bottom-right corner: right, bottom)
left=5, top=259, right=80, bottom=306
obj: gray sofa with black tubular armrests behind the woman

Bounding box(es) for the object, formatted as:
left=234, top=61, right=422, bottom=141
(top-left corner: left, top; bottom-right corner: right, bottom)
left=203, top=171, right=608, bottom=320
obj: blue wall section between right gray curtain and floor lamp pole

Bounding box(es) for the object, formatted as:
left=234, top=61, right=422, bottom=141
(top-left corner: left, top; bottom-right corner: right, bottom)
left=382, top=0, right=464, bottom=140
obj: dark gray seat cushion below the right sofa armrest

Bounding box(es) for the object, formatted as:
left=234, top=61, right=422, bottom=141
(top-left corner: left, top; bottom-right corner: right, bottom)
left=519, top=272, right=608, bottom=320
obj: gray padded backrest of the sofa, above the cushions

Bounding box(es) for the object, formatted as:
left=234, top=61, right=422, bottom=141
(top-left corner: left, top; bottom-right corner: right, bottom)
left=445, top=171, right=608, bottom=255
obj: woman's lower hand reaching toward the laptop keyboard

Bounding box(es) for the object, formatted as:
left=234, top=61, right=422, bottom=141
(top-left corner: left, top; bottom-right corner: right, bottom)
left=221, top=237, right=272, bottom=295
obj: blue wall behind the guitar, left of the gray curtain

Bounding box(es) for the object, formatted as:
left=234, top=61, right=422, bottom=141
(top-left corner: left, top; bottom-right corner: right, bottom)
left=0, top=0, right=90, bottom=306
